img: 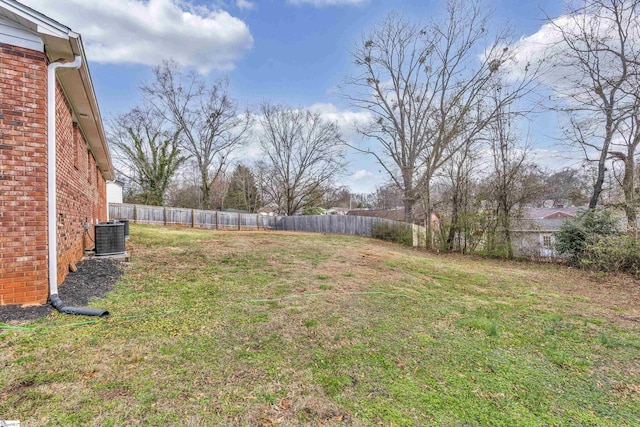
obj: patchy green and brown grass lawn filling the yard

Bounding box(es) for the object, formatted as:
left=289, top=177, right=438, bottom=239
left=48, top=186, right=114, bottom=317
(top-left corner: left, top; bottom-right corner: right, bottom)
left=0, top=226, right=640, bottom=426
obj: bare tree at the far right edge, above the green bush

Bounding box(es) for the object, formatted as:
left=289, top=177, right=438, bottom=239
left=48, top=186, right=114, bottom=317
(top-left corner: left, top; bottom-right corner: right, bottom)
left=550, top=0, right=640, bottom=209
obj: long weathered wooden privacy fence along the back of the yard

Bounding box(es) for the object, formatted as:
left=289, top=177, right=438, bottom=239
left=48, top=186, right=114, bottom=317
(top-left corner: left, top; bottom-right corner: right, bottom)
left=109, top=203, right=425, bottom=246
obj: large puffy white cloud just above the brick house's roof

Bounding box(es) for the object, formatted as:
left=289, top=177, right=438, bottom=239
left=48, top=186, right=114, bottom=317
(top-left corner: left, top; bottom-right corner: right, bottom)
left=21, top=0, right=253, bottom=73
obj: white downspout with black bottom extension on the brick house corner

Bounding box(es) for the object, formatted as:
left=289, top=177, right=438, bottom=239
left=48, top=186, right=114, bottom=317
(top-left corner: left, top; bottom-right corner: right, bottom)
left=47, top=56, right=109, bottom=317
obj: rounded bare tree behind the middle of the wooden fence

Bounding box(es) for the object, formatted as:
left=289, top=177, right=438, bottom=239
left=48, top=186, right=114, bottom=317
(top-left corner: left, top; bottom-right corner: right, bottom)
left=259, top=103, right=344, bottom=215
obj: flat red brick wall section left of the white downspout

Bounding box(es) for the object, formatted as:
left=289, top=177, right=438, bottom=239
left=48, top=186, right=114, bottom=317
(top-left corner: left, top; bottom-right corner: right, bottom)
left=0, top=44, right=48, bottom=305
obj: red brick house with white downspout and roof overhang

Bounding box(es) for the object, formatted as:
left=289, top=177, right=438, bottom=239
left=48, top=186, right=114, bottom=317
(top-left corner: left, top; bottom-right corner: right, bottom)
left=0, top=0, right=113, bottom=305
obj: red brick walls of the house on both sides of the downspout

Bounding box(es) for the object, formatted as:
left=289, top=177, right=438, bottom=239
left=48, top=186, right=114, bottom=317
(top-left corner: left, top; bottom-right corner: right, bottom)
left=0, top=44, right=107, bottom=305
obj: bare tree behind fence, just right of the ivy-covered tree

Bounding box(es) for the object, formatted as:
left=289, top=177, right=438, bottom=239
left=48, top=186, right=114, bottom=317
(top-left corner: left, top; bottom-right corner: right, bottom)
left=142, top=62, right=251, bottom=209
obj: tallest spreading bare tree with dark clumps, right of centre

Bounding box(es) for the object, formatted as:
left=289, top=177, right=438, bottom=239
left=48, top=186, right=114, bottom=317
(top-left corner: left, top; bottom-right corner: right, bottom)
left=343, top=0, right=533, bottom=231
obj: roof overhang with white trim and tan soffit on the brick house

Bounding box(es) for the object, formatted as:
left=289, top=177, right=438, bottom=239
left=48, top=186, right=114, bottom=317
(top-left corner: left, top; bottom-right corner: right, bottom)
left=0, top=0, right=114, bottom=180
